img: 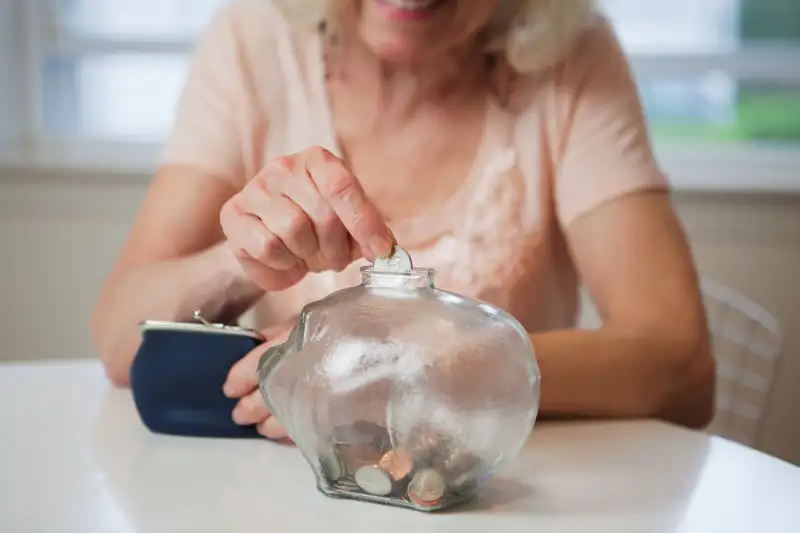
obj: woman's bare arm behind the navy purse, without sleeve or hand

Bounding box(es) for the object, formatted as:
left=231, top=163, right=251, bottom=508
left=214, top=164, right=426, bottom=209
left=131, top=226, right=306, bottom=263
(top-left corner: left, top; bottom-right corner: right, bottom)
left=92, top=166, right=263, bottom=385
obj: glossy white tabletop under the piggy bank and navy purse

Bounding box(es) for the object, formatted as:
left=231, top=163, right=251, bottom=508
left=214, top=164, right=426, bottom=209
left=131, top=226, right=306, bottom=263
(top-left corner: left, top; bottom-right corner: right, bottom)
left=0, top=362, right=800, bottom=533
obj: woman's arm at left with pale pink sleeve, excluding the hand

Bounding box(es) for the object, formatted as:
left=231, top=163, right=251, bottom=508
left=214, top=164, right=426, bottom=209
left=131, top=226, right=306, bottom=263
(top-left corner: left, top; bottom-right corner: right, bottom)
left=92, top=2, right=263, bottom=385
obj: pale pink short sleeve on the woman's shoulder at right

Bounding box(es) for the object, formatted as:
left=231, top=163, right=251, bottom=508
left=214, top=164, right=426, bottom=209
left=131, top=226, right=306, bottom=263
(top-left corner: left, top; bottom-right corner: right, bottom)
left=554, top=21, right=667, bottom=227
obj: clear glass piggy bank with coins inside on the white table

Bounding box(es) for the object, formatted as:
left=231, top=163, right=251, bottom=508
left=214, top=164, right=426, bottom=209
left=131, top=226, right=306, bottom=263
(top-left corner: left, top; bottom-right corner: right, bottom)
left=258, top=248, right=540, bottom=511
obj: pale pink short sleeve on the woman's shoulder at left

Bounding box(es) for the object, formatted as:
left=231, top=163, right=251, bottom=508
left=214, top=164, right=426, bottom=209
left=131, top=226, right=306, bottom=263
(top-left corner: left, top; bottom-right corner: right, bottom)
left=161, top=5, right=244, bottom=184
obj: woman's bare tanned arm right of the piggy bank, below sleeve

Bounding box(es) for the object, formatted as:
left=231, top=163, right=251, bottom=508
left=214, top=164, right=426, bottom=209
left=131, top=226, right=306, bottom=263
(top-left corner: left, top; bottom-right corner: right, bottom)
left=531, top=192, right=715, bottom=427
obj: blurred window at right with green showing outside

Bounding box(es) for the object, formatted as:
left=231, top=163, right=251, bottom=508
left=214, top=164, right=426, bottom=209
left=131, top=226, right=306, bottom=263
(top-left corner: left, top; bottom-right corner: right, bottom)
left=602, top=0, right=800, bottom=148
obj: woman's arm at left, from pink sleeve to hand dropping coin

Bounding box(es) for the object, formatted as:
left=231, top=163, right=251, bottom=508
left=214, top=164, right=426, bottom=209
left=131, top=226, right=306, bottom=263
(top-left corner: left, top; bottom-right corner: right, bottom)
left=92, top=2, right=393, bottom=385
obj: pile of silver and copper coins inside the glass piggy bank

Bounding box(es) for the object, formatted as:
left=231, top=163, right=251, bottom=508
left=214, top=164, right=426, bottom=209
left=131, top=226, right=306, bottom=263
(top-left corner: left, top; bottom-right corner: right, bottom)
left=319, top=422, right=481, bottom=509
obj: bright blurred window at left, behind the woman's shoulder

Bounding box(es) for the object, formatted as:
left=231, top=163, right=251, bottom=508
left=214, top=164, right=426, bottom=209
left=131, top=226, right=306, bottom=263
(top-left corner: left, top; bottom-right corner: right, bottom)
left=25, top=0, right=224, bottom=142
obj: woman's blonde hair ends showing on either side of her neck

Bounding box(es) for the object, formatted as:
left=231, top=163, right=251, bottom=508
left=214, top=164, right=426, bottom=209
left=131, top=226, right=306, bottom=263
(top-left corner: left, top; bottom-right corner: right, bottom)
left=272, top=0, right=597, bottom=73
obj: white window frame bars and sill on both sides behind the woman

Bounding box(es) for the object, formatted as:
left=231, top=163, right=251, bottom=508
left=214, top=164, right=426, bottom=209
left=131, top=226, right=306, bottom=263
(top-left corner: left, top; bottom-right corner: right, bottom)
left=0, top=0, right=800, bottom=193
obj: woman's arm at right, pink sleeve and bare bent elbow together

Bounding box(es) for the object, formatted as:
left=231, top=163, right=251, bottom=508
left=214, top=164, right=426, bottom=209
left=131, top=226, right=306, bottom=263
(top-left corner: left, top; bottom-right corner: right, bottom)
left=532, top=21, right=715, bottom=427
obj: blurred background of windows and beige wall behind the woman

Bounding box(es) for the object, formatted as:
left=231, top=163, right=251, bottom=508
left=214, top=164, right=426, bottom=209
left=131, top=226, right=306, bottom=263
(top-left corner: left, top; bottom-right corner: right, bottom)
left=0, top=0, right=800, bottom=464
